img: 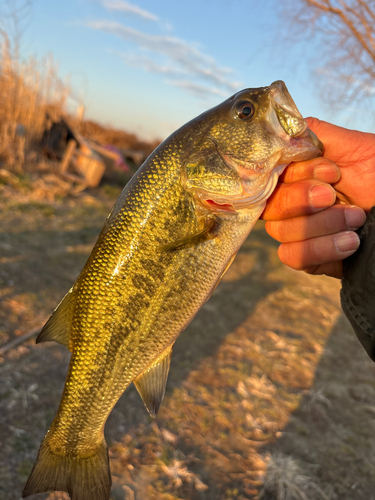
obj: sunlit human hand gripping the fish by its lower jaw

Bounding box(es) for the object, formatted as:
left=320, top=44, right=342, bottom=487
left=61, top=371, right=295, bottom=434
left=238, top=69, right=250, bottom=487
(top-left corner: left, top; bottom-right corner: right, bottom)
left=262, top=118, right=375, bottom=278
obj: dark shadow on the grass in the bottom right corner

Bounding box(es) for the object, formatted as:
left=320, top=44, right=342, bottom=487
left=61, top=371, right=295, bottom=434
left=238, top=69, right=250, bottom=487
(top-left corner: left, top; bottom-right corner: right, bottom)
left=262, top=314, right=375, bottom=500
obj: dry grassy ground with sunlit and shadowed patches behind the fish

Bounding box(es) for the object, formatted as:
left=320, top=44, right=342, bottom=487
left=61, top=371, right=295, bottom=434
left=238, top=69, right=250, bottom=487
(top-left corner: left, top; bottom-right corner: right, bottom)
left=0, top=180, right=375, bottom=500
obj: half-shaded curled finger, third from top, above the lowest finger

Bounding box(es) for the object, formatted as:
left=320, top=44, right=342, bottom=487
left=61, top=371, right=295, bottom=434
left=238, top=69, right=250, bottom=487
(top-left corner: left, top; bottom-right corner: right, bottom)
left=266, top=205, right=366, bottom=243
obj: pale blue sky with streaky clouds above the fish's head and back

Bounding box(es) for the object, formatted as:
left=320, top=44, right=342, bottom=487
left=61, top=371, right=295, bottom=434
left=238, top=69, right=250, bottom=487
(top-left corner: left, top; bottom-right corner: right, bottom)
left=18, top=0, right=375, bottom=139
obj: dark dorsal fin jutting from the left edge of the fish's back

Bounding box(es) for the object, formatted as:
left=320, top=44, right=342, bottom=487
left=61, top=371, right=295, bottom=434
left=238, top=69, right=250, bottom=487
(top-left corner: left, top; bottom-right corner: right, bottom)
left=36, top=288, right=75, bottom=349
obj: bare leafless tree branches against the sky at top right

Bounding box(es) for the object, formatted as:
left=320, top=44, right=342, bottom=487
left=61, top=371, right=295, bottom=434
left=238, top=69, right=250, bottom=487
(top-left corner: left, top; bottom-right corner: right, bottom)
left=278, top=0, right=375, bottom=106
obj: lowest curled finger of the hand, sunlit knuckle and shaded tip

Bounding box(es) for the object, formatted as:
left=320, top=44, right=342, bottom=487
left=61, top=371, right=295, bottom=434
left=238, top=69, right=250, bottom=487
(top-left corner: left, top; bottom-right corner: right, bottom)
left=278, top=231, right=359, bottom=271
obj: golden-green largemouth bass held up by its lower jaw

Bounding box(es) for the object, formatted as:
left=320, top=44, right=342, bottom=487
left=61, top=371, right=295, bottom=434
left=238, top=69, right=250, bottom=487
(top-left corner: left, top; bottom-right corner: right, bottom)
left=22, top=81, right=323, bottom=500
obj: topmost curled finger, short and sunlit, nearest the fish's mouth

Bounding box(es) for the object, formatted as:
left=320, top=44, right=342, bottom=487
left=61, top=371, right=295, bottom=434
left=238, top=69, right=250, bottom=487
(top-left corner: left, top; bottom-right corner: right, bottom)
left=280, top=156, right=340, bottom=184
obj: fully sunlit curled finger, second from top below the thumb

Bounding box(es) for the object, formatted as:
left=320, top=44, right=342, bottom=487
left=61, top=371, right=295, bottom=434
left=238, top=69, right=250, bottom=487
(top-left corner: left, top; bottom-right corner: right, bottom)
left=262, top=179, right=336, bottom=220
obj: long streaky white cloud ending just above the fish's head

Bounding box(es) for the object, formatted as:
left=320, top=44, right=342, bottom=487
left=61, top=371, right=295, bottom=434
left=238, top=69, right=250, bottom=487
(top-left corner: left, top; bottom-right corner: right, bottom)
left=85, top=20, right=240, bottom=94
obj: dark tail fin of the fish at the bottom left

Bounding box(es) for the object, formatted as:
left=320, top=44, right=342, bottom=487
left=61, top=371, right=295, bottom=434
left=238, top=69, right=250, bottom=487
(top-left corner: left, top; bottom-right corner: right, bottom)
left=22, top=435, right=112, bottom=500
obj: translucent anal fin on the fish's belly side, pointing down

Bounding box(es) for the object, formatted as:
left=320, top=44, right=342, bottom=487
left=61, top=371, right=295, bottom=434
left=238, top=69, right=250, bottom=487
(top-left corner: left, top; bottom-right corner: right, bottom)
left=134, top=346, right=173, bottom=417
